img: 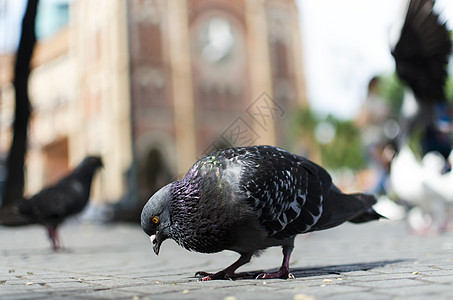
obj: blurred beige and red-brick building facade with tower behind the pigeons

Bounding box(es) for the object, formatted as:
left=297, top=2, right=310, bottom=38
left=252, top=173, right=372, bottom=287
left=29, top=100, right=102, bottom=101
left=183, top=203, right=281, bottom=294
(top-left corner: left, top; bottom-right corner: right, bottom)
left=0, top=0, right=306, bottom=210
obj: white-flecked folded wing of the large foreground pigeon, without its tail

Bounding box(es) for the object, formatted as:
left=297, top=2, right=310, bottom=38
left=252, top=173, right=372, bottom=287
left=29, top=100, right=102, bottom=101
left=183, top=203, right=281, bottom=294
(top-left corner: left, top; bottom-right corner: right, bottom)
left=249, top=159, right=324, bottom=239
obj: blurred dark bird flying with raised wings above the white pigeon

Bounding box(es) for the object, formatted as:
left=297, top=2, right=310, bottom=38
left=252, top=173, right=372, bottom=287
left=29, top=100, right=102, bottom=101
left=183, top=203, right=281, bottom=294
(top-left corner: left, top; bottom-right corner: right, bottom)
left=391, top=0, right=452, bottom=147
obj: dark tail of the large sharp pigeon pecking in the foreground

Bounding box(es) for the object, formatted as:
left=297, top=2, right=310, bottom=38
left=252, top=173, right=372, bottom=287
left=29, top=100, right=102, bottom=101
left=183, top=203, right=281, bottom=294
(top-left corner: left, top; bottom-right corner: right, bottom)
left=312, top=188, right=383, bottom=230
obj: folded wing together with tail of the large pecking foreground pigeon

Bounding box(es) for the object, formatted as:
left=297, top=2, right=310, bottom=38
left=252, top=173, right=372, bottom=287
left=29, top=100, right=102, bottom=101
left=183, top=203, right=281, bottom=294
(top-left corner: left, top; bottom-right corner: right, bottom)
left=217, top=146, right=377, bottom=239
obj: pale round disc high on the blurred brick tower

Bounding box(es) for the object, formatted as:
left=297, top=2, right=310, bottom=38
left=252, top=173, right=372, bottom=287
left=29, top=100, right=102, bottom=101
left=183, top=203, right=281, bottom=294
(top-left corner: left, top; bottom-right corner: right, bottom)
left=199, top=16, right=236, bottom=64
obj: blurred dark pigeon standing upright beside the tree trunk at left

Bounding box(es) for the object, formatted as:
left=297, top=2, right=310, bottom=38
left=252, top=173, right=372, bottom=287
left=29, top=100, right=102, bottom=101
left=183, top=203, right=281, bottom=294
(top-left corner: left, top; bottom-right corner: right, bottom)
left=17, top=156, right=102, bottom=250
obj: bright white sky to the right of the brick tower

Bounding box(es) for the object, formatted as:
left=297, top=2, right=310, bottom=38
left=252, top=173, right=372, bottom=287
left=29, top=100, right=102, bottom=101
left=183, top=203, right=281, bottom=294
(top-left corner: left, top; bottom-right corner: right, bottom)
left=296, top=0, right=453, bottom=119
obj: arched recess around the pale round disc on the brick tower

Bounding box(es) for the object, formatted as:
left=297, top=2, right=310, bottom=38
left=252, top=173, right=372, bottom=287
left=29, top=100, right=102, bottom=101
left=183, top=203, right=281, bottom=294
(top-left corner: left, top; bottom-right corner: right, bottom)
left=191, top=10, right=247, bottom=103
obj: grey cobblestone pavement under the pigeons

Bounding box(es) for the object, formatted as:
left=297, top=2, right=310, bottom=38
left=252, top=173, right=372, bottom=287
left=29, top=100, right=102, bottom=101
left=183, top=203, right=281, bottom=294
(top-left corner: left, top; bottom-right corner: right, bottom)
left=0, top=221, right=453, bottom=300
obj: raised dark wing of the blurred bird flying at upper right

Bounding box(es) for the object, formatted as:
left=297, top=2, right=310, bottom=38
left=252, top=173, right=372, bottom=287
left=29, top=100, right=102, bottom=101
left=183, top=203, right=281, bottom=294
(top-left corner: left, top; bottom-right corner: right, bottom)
left=392, top=0, right=452, bottom=103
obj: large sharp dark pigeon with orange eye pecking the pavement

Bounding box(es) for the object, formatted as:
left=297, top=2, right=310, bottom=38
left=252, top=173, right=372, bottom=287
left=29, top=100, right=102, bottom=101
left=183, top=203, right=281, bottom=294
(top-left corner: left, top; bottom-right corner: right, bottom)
left=141, top=146, right=382, bottom=281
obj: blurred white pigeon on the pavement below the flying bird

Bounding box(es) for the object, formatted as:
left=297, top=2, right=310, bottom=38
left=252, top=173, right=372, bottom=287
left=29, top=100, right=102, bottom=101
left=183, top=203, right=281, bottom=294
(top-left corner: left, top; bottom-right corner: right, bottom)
left=390, top=145, right=453, bottom=235
